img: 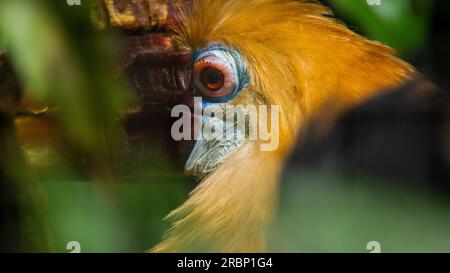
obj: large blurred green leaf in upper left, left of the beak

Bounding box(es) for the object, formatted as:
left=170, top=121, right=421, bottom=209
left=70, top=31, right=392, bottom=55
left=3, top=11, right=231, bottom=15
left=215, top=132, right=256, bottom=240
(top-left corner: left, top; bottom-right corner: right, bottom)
left=0, top=0, right=130, bottom=155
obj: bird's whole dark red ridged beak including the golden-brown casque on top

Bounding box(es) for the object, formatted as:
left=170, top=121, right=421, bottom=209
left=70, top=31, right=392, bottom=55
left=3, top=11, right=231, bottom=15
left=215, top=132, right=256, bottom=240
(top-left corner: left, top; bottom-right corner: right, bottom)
left=101, top=0, right=193, bottom=171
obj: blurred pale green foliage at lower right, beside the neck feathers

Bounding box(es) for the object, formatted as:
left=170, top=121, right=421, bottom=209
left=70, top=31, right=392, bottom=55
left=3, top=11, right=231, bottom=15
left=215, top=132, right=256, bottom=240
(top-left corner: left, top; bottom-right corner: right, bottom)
left=271, top=168, right=450, bottom=253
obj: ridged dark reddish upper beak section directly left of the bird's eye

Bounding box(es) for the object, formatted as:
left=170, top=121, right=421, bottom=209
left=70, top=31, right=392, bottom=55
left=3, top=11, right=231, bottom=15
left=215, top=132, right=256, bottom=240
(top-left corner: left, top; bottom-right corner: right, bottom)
left=119, top=33, right=192, bottom=108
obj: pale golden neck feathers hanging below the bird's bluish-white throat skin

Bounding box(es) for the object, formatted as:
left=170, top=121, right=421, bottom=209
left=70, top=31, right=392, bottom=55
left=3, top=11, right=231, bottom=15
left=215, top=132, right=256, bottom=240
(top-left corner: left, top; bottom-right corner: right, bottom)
left=152, top=142, right=282, bottom=252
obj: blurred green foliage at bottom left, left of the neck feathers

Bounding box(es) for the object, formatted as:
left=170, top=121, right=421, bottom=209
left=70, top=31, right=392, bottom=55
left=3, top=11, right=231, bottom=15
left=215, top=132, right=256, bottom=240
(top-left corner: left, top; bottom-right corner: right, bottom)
left=44, top=179, right=187, bottom=253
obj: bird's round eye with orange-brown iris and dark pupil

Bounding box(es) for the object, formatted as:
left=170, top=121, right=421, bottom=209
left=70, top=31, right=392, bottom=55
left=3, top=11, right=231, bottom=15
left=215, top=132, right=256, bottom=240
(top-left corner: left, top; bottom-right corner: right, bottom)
left=193, top=55, right=236, bottom=100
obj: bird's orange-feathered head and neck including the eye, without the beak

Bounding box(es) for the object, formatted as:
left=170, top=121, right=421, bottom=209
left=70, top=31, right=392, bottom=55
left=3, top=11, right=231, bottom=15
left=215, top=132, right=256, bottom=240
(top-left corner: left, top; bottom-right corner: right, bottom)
left=152, top=0, right=417, bottom=252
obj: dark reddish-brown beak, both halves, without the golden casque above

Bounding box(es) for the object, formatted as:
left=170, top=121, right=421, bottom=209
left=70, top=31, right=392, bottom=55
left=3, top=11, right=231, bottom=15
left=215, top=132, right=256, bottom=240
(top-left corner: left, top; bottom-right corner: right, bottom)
left=119, top=33, right=193, bottom=170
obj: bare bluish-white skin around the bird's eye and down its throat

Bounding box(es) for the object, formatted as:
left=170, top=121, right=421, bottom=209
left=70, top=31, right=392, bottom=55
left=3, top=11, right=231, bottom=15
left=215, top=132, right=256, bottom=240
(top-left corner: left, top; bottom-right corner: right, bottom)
left=185, top=44, right=253, bottom=180
